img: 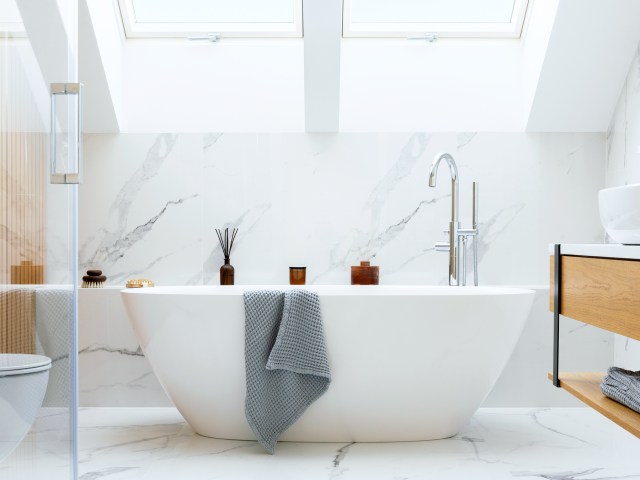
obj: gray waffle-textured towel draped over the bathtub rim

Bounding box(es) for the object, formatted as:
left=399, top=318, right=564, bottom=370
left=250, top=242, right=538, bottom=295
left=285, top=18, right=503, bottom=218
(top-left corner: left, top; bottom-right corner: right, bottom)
left=244, top=290, right=331, bottom=454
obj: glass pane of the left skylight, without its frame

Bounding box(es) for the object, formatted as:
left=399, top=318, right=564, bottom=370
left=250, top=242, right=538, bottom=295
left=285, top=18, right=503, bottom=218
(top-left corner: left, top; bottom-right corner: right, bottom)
left=133, top=0, right=295, bottom=23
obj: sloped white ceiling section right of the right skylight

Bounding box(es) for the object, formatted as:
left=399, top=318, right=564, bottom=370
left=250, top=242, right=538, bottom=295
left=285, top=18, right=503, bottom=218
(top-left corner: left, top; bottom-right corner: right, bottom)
left=526, top=0, right=640, bottom=132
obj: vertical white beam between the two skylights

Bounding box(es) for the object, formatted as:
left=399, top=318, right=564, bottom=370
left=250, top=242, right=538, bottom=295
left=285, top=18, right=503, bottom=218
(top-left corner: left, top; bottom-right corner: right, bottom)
left=303, top=0, right=342, bottom=133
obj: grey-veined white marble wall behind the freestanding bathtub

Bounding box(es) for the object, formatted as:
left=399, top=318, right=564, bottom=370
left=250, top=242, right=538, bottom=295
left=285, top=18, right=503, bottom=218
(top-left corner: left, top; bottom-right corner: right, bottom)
left=79, top=133, right=613, bottom=406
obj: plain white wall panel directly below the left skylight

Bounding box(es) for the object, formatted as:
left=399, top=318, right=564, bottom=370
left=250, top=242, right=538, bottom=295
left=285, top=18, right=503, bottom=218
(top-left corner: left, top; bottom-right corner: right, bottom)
left=121, top=40, right=304, bottom=133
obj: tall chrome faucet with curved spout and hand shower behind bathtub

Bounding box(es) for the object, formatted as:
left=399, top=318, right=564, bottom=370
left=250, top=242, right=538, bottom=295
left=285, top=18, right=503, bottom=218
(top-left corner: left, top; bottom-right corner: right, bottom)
left=429, top=153, right=478, bottom=287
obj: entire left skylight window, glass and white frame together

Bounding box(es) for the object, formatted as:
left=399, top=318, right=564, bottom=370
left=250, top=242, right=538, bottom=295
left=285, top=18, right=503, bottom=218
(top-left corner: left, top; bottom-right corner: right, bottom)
left=119, top=0, right=302, bottom=38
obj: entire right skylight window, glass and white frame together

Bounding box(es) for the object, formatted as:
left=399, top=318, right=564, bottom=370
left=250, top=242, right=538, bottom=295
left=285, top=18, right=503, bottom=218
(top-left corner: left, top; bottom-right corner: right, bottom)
left=343, top=0, right=528, bottom=38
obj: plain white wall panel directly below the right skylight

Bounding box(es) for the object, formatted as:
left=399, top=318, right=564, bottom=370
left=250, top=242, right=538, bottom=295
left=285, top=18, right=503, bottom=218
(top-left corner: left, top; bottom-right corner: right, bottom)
left=340, top=39, right=525, bottom=132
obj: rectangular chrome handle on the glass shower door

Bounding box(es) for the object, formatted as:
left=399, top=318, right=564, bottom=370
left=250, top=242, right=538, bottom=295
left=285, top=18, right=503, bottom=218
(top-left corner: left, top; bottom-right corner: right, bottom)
left=50, top=83, right=83, bottom=184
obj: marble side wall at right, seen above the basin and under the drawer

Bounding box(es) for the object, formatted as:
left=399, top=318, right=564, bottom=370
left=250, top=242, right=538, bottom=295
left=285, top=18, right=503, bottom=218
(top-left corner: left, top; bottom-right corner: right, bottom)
left=605, top=45, right=640, bottom=370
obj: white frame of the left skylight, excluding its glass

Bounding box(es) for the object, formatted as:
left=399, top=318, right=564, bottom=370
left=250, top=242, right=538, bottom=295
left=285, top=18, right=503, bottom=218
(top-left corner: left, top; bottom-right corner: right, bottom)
left=117, top=0, right=303, bottom=39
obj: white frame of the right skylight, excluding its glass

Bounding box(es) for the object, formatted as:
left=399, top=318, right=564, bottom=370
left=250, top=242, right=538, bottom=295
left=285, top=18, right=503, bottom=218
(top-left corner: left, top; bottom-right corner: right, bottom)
left=342, top=0, right=531, bottom=39
